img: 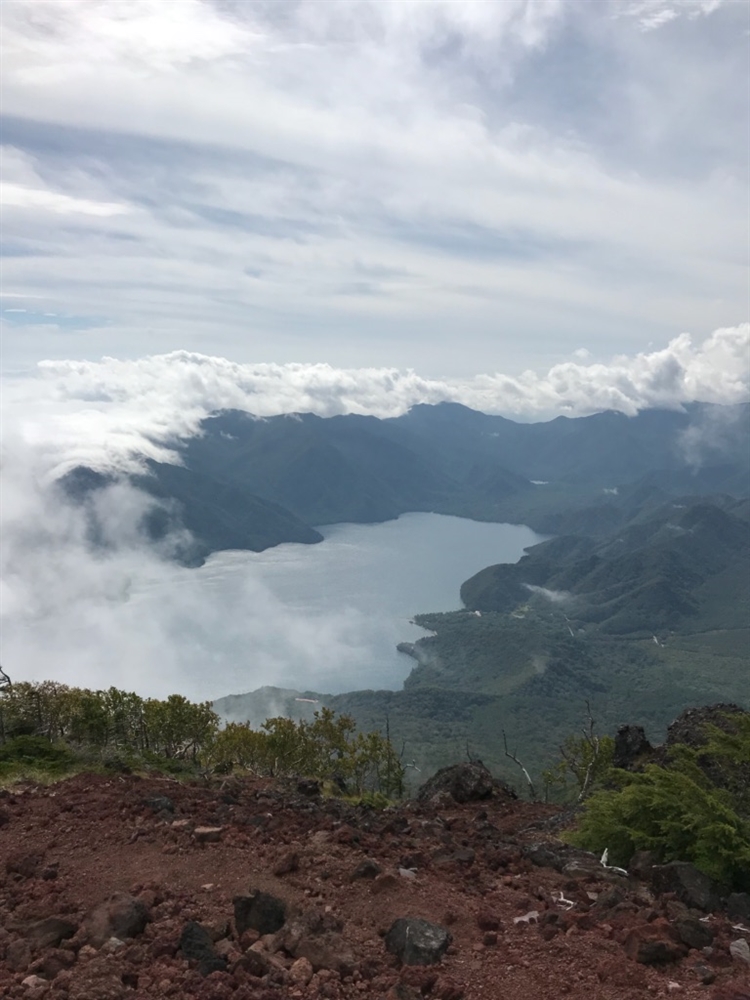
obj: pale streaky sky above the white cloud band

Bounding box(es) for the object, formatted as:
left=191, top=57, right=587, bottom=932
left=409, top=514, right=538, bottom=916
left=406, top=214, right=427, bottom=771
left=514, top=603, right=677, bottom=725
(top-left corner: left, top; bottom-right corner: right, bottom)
left=0, top=0, right=750, bottom=379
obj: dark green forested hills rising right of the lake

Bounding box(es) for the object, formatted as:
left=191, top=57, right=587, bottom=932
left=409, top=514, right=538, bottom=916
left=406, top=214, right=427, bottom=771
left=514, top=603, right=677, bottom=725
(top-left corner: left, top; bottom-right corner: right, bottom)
left=461, top=498, right=750, bottom=636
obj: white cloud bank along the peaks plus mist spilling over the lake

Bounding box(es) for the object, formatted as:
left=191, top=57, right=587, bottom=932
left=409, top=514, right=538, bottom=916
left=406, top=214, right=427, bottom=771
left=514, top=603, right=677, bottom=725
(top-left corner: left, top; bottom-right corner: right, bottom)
left=0, top=324, right=750, bottom=697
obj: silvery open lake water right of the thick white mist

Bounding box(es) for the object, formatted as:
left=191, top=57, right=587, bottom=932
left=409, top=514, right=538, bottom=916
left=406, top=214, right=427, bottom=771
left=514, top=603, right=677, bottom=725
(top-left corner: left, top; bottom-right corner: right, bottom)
left=190, top=514, right=542, bottom=697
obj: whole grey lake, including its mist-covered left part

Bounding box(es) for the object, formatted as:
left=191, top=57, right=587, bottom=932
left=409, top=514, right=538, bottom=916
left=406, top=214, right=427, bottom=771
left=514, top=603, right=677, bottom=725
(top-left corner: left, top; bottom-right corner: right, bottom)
left=2, top=514, right=541, bottom=701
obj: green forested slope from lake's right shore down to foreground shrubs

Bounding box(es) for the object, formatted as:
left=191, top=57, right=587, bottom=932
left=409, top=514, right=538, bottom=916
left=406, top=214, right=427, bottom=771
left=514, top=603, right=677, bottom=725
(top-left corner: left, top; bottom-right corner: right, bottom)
left=215, top=497, right=750, bottom=776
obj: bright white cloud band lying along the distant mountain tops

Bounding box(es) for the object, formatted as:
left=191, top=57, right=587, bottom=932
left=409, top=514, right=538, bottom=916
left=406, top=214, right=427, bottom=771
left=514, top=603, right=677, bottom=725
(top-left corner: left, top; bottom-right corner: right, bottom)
left=3, top=323, right=750, bottom=476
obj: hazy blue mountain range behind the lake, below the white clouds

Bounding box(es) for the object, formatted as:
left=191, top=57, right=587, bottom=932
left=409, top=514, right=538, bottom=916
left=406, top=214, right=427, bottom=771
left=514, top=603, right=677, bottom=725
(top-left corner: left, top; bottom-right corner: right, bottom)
left=63, top=403, right=750, bottom=563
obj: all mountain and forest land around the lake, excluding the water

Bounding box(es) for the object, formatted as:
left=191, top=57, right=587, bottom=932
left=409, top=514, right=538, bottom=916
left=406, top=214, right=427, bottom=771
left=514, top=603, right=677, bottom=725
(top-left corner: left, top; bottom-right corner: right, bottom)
left=55, top=404, right=750, bottom=781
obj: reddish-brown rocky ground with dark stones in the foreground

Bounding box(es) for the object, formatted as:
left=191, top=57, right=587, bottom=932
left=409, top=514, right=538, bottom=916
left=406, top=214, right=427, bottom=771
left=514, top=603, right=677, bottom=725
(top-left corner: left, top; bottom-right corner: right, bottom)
left=0, top=760, right=750, bottom=1000
